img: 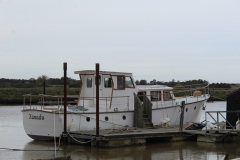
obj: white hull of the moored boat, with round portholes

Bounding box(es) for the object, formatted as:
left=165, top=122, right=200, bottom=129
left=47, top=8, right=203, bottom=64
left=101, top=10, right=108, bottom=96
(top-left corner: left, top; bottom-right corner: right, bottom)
left=22, top=97, right=206, bottom=140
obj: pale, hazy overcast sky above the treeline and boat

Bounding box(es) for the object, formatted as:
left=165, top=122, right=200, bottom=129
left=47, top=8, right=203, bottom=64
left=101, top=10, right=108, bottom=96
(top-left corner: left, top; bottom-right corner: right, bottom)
left=0, top=0, right=240, bottom=83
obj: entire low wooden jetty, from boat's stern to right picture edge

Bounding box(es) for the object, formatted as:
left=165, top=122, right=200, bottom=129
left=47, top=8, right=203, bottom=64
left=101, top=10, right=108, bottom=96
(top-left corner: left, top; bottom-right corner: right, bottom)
left=68, top=126, right=240, bottom=147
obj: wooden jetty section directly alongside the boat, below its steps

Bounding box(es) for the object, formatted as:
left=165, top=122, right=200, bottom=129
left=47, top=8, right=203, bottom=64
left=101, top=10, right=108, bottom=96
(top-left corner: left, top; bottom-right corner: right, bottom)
left=68, top=127, right=184, bottom=147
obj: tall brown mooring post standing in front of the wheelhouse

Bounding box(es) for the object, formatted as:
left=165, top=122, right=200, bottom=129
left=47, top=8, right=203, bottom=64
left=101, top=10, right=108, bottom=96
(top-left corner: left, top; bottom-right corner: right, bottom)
left=95, top=63, right=99, bottom=147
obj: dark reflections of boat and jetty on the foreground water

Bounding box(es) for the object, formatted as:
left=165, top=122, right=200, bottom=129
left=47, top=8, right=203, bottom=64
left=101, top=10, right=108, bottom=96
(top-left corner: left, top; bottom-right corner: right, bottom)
left=22, top=141, right=234, bottom=160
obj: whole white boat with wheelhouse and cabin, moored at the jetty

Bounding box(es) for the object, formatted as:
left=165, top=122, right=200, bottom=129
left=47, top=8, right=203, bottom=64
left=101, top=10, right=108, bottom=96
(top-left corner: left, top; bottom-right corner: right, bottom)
left=22, top=70, right=210, bottom=140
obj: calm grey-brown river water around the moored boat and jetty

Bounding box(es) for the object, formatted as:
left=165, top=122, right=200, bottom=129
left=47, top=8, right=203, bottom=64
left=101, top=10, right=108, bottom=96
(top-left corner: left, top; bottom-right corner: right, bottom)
left=0, top=102, right=240, bottom=160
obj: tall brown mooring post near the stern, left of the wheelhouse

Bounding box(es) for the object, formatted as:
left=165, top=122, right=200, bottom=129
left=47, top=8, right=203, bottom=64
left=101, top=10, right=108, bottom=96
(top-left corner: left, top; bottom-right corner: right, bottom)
left=63, top=62, right=67, bottom=144
